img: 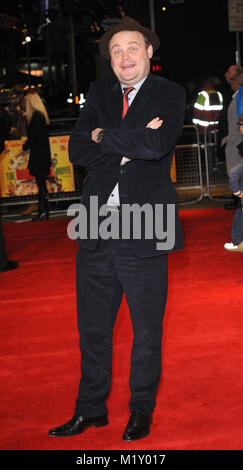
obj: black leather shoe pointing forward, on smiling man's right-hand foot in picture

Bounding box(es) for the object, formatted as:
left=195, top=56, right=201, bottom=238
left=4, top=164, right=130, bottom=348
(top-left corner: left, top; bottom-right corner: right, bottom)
left=123, top=411, right=152, bottom=441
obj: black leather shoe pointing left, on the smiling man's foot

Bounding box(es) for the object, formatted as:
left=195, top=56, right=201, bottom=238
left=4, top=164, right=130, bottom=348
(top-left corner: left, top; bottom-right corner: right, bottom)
left=48, top=415, right=108, bottom=437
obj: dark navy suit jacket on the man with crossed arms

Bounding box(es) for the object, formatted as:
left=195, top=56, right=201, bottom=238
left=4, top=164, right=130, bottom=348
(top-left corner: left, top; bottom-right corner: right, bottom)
left=69, top=74, right=186, bottom=257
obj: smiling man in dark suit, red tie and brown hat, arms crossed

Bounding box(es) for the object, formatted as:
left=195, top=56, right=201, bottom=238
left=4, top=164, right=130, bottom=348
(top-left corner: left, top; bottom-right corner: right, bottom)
left=49, top=17, right=186, bottom=441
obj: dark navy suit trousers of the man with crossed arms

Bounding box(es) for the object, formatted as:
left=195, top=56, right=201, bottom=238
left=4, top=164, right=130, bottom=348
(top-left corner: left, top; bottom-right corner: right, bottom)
left=75, top=239, right=168, bottom=417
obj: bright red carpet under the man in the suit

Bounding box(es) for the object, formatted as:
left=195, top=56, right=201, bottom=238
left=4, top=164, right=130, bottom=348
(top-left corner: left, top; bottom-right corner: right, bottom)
left=0, top=209, right=243, bottom=450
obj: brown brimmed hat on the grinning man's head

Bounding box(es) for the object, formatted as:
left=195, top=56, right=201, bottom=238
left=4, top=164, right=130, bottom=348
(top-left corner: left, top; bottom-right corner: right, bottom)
left=99, top=16, right=160, bottom=59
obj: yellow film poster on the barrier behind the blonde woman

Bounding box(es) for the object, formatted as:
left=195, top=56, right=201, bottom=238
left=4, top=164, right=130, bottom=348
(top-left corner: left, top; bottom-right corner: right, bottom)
left=0, top=136, right=75, bottom=197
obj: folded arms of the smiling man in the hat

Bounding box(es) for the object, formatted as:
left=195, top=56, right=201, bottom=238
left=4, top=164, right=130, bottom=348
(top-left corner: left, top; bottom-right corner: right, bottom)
left=69, top=80, right=185, bottom=170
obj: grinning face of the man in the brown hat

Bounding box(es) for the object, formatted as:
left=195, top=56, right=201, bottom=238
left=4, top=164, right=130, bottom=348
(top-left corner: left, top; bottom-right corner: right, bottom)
left=109, top=31, right=153, bottom=86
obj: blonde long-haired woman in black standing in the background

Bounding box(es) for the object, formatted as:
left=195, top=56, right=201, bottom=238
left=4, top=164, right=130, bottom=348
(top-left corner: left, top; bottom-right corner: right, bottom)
left=23, top=91, right=51, bottom=220
